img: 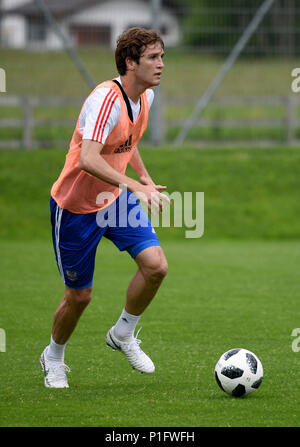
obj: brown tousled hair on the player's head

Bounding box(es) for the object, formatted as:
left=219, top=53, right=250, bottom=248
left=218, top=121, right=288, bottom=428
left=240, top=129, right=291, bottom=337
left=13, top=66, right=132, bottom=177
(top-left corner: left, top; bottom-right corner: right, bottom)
left=115, top=26, right=164, bottom=76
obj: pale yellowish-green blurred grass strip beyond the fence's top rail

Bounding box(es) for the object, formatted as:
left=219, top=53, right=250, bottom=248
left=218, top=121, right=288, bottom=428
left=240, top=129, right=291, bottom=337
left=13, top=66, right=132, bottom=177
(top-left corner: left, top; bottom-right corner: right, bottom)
left=0, top=49, right=299, bottom=98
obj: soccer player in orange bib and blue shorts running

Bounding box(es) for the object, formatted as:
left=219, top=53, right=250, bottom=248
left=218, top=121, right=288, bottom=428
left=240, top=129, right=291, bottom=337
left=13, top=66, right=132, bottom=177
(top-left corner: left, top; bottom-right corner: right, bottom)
left=40, top=27, right=170, bottom=388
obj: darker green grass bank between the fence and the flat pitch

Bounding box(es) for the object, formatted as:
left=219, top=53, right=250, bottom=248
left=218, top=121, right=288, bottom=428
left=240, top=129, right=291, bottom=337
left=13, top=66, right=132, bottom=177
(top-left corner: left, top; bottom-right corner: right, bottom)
left=0, top=144, right=300, bottom=240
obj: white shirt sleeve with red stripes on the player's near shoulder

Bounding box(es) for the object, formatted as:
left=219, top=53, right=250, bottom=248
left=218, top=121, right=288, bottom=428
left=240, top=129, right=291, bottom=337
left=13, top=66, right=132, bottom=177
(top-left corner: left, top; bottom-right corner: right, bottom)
left=79, top=88, right=121, bottom=144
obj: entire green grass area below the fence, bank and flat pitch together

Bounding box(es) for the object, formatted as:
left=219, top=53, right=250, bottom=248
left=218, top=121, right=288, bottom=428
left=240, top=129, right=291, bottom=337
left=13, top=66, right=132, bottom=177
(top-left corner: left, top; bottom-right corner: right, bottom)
left=0, top=147, right=300, bottom=427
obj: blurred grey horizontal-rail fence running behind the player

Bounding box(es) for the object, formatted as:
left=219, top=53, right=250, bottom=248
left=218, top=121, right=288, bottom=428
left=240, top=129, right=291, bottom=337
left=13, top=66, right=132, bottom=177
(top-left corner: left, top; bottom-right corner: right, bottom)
left=0, top=95, right=300, bottom=149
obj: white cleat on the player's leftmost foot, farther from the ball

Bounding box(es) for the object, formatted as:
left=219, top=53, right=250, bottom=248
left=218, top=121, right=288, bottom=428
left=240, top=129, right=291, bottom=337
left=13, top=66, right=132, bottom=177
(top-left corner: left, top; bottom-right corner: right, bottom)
left=40, top=347, right=71, bottom=388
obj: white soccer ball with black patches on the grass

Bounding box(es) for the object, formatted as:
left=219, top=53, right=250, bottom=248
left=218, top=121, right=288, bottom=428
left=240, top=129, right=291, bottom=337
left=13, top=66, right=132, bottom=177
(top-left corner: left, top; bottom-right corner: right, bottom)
left=215, top=348, right=263, bottom=397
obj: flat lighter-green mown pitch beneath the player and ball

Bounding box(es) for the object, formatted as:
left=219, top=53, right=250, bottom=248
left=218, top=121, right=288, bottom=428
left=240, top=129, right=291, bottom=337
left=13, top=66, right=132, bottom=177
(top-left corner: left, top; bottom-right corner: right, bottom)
left=0, top=238, right=300, bottom=427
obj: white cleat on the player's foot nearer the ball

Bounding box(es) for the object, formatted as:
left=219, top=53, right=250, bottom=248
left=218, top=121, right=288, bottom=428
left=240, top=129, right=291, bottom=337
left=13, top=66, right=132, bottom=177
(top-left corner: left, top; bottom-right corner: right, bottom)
left=105, top=326, right=155, bottom=374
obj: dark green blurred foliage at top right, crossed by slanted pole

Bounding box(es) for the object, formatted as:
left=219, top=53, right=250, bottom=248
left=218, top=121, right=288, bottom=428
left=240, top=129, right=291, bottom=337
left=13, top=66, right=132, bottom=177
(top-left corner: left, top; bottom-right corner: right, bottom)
left=183, top=0, right=300, bottom=55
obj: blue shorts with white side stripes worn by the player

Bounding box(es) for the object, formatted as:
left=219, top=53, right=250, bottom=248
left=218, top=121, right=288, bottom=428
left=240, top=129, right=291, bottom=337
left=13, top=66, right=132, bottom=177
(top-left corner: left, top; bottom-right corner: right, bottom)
left=50, top=191, right=160, bottom=289
